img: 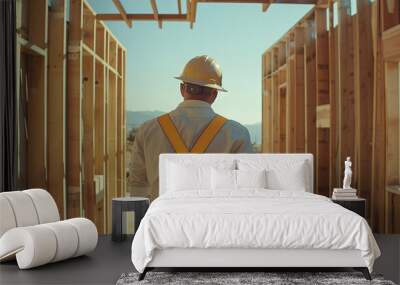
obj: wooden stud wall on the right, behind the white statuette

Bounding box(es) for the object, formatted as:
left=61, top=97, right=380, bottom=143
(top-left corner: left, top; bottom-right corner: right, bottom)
left=262, top=0, right=400, bottom=232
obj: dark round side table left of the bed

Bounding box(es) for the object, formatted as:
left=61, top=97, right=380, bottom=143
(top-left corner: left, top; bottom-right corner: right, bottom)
left=111, top=197, right=150, bottom=241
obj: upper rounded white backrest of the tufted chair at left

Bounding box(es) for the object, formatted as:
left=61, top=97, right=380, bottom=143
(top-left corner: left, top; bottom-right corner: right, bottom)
left=0, top=189, right=60, bottom=237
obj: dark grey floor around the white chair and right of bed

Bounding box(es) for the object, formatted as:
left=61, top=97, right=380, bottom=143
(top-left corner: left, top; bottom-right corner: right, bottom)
left=0, top=235, right=400, bottom=285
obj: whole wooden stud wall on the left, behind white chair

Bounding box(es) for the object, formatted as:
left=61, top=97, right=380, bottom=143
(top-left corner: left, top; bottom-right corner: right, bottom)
left=16, top=0, right=126, bottom=233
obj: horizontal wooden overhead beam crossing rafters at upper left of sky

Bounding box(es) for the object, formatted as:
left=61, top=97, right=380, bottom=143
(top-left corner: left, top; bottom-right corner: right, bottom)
left=96, top=14, right=188, bottom=22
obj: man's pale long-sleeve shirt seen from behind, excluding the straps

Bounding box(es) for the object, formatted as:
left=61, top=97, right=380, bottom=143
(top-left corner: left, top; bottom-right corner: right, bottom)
left=129, top=100, right=253, bottom=200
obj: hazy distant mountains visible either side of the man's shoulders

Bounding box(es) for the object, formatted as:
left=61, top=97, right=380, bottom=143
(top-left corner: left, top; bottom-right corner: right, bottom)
left=126, top=111, right=261, bottom=144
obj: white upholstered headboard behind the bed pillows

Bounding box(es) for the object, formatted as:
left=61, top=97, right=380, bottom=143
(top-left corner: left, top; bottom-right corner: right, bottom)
left=159, top=153, right=314, bottom=195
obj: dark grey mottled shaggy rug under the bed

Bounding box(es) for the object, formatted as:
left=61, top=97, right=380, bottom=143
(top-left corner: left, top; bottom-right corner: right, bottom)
left=117, top=272, right=395, bottom=285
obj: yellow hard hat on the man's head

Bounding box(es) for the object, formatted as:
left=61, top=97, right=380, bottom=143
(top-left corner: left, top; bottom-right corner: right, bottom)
left=175, top=55, right=226, bottom=92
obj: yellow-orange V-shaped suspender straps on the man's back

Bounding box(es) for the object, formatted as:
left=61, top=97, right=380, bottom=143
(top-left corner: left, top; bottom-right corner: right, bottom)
left=158, top=114, right=227, bottom=153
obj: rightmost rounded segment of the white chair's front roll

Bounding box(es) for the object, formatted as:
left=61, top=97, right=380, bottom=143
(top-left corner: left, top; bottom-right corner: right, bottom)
left=63, top=218, right=98, bottom=257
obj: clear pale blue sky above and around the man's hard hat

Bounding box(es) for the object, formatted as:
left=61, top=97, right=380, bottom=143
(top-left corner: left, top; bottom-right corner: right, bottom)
left=89, top=0, right=312, bottom=124
